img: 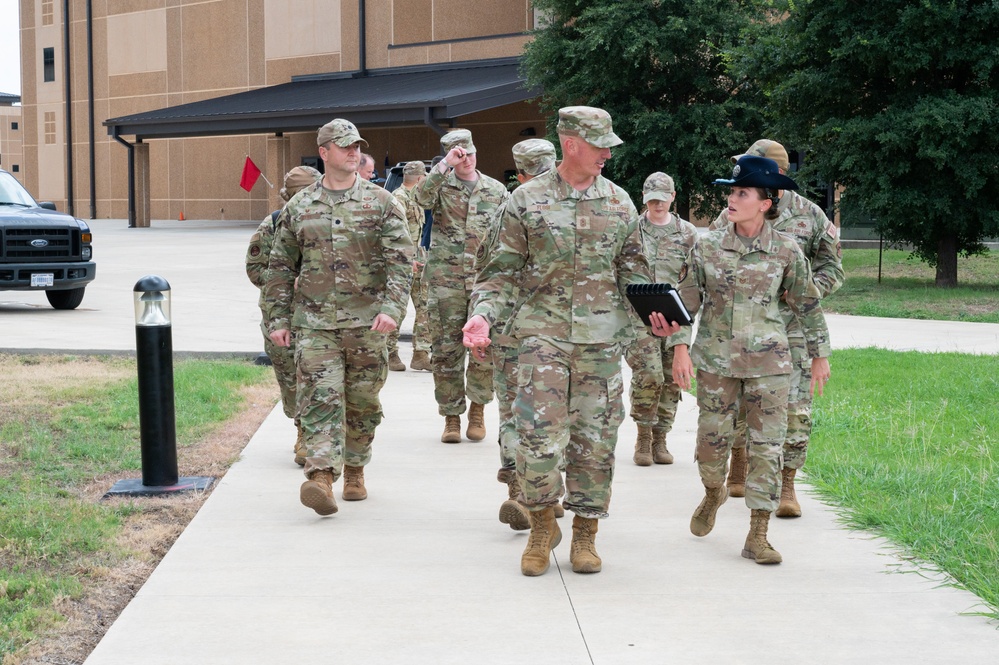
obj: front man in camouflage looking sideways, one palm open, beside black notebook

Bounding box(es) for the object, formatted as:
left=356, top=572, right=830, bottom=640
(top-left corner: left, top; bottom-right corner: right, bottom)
left=465, top=106, right=668, bottom=576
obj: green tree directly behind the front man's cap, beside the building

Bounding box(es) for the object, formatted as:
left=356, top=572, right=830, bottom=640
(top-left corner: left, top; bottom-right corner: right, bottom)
left=524, top=0, right=762, bottom=217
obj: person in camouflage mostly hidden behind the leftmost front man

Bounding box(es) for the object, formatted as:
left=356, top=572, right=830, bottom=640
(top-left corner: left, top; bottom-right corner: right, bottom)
left=246, top=166, right=322, bottom=466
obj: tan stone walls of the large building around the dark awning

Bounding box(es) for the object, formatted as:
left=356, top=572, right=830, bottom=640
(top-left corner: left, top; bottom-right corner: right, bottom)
left=19, top=0, right=544, bottom=220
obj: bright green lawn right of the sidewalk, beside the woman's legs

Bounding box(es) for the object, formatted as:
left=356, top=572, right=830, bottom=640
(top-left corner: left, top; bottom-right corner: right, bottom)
left=805, top=349, right=999, bottom=619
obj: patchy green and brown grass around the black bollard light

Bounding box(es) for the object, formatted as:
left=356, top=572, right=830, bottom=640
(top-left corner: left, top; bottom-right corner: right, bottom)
left=0, top=357, right=270, bottom=660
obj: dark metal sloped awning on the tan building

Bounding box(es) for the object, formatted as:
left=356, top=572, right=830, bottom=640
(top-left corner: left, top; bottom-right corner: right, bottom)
left=104, top=58, right=540, bottom=140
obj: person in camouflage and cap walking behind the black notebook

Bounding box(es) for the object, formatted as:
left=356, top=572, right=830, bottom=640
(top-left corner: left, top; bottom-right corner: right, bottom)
left=625, top=172, right=697, bottom=466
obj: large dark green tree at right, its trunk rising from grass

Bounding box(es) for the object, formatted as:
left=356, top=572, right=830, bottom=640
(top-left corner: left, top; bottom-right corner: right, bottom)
left=733, top=0, right=999, bottom=286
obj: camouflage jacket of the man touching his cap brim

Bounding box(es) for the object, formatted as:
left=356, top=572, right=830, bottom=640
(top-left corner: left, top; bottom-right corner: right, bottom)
left=413, top=168, right=509, bottom=291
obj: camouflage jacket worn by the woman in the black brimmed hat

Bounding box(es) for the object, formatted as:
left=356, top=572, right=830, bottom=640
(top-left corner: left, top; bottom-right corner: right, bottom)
left=681, top=224, right=831, bottom=378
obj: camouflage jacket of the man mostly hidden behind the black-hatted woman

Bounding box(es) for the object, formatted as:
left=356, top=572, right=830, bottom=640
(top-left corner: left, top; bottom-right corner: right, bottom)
left=711, top=189, right=845, bottom=337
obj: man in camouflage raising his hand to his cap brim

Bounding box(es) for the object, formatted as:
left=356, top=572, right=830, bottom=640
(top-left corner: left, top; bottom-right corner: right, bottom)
left=413, top=129, right=508, bottom=443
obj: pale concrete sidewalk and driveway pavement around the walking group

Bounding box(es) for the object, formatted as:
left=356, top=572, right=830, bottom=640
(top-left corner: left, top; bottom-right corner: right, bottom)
left=0, top=220, right=999, bottom=665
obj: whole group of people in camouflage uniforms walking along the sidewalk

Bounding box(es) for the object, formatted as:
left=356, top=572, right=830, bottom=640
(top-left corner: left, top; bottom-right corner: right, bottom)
left=247, top=106, right=843, bottom=576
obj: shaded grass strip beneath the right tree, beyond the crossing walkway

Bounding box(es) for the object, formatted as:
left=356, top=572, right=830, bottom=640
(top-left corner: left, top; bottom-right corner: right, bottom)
left=822, top=249, right=999, bottom=323
